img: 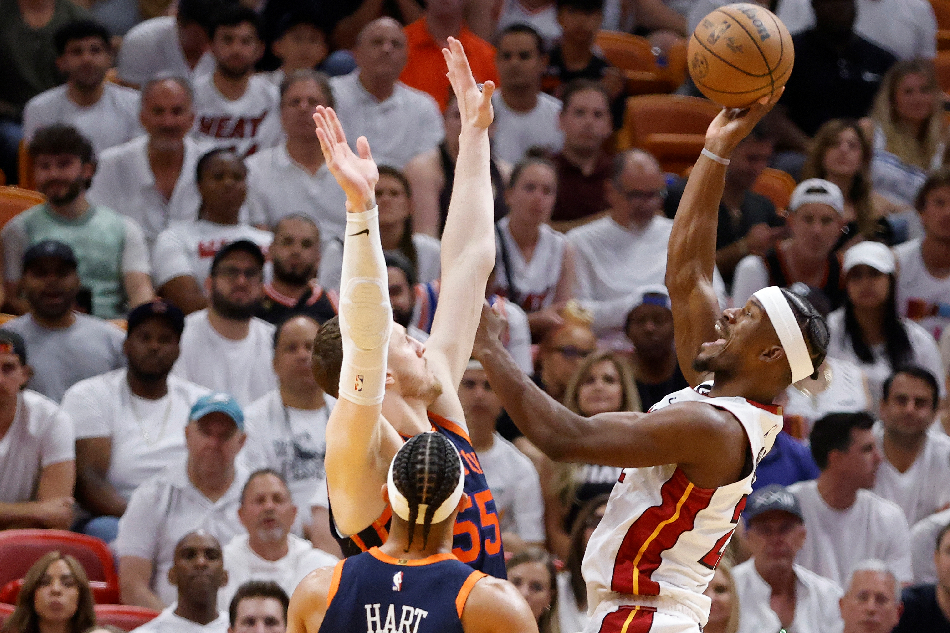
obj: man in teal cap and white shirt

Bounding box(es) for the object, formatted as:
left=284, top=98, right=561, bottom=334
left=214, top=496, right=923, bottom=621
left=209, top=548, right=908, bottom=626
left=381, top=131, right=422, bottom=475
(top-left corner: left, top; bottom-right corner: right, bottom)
left=115, top=393, right=247, bottom=608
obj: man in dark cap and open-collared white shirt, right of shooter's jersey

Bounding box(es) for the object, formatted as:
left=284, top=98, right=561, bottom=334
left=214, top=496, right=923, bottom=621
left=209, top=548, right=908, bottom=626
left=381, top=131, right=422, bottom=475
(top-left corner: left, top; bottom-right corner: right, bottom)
left=732, top=484, right=842, bottom=633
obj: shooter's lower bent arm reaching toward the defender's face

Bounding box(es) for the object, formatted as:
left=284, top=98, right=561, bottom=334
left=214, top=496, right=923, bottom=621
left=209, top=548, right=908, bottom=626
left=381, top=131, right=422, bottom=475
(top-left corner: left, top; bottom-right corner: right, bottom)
left=473, top=306, right=748, bottom=488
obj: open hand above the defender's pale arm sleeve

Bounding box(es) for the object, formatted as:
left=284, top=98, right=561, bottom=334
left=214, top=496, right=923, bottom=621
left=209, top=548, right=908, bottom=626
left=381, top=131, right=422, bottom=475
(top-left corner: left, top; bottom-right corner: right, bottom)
left=313, top=106, right=379, bottom=213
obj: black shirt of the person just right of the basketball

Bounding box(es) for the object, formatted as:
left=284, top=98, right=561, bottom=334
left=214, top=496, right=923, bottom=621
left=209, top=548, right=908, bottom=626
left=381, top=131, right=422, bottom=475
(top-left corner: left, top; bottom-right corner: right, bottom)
left=779, top=29, right=897, bottom=136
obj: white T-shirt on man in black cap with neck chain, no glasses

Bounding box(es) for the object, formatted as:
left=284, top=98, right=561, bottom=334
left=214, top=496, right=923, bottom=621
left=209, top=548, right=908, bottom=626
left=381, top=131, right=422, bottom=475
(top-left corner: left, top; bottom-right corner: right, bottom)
left=62, top=369, right=208, bottom=501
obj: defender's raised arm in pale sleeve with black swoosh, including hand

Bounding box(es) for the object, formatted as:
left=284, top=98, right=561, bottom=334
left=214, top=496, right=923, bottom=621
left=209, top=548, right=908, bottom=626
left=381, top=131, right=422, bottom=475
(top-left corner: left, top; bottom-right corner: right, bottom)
left=313, top=107, right=402, bottom=535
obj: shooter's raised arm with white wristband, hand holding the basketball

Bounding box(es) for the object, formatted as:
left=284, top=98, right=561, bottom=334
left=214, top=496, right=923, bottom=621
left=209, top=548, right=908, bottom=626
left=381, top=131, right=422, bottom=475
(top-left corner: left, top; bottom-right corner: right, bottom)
left=666, top=92, right=781, bottom=385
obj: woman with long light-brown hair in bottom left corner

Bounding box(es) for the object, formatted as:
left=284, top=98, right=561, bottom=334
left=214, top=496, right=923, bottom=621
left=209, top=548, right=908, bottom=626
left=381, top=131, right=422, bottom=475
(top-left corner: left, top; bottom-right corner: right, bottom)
left=2, top=552, right=96, bottom=633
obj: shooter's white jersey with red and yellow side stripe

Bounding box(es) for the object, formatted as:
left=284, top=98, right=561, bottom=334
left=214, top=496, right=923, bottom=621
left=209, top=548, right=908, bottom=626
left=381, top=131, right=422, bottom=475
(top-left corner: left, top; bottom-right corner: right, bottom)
left=582, top=383, right=782, bottom=631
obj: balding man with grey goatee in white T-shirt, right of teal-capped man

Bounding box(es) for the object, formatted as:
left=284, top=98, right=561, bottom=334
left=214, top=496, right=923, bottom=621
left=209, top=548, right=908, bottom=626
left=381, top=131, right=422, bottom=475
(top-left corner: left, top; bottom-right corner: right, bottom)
left=218, top=469, right=338, bottom=605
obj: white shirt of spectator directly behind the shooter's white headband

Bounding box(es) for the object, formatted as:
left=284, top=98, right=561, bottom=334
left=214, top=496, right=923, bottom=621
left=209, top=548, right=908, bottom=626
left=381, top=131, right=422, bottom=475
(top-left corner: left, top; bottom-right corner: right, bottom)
left=782, top=358, right=872, bottom=437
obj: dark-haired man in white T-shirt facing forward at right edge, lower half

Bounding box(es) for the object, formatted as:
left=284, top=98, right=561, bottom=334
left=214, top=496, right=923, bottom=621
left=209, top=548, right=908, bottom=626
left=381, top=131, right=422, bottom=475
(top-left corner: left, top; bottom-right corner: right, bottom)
left=873, top=365, right=950, bottom=525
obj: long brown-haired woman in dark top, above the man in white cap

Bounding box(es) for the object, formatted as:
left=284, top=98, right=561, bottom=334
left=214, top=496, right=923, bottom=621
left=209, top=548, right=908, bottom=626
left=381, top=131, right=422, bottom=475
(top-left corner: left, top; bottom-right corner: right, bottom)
left=802, top=119, right=901, bottom=250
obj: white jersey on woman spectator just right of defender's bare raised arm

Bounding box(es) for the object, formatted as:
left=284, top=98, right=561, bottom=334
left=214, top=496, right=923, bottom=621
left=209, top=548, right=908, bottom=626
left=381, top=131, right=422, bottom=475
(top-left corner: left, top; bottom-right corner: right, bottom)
left=495, top=216, right=567, bottom=312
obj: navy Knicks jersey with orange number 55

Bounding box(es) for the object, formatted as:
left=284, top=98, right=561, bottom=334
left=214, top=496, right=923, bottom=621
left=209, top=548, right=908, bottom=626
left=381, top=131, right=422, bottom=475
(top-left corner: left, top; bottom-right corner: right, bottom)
left=330, top=412, right=508, bottom=579
